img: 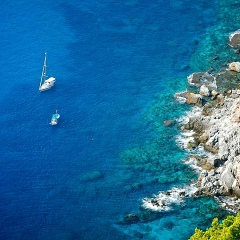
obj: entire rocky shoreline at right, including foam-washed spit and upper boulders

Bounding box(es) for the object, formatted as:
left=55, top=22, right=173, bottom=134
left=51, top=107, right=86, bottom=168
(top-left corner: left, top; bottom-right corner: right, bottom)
left=119, top=30, right=240, bottom=224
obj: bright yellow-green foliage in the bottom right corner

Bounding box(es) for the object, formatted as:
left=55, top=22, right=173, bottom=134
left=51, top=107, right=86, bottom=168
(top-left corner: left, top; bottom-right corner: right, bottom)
left=190, top=212, right=240, bottom=240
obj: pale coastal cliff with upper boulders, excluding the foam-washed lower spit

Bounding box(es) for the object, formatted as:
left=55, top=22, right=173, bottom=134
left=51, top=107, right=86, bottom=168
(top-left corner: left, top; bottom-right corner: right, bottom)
left=182, top=30, right=240, bottom=200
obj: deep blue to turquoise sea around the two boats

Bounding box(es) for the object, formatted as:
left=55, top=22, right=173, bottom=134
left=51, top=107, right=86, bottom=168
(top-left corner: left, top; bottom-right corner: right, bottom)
left=0, top=0, right=240, bottom=240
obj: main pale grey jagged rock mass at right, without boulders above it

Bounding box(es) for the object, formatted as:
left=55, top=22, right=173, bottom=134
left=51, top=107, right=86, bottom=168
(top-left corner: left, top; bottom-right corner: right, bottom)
left=183, top=94, right=240, bottom=196
